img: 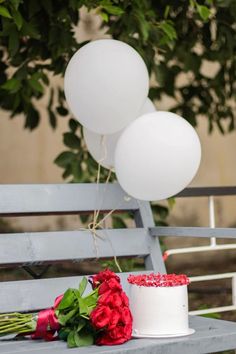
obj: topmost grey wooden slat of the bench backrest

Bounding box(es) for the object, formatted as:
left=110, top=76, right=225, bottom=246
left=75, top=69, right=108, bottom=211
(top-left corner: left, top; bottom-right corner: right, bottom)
left=0, top=183, right=138, bottom=216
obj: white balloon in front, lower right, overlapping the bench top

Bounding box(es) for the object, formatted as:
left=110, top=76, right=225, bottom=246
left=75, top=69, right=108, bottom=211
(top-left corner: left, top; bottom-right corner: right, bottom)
left=115, top=111, right=201, bottom=201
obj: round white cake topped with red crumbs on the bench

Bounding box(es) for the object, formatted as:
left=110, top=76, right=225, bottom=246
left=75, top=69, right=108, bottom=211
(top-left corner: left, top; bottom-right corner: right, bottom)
left=128, top=274, right=194, bottom=337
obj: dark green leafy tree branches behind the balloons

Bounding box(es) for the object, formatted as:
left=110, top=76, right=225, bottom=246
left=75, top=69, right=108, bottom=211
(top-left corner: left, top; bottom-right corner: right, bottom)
left=0, top=0, right=236, bottom=194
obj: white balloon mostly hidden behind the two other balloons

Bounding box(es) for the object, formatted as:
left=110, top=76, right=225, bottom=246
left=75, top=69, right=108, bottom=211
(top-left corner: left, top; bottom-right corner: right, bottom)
left=83, top=98, right=156, bottom=170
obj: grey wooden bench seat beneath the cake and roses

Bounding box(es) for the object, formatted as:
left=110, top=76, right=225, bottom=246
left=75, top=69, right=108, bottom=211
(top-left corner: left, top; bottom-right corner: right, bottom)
left=0, top=316, right=236, bottom=354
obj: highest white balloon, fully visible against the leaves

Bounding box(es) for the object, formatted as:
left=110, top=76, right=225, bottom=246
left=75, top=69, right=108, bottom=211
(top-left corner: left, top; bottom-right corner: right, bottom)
left=64, top=39, right=149, bottom=134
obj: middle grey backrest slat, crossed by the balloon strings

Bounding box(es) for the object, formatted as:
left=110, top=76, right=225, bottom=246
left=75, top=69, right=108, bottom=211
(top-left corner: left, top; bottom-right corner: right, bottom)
left=0, top=228, right=150, bottom=265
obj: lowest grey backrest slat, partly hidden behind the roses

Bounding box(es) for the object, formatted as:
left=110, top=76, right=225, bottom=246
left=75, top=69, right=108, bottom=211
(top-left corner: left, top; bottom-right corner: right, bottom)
left=0, top=271, right=150, bottom=313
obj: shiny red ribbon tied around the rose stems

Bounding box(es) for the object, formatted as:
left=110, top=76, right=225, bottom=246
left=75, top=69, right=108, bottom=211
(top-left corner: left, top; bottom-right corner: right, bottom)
left=31, top=295, right=63, bottom=341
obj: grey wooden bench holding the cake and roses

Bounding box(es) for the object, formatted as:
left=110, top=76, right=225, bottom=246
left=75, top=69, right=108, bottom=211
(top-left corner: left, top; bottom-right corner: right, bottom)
left=0, top=184, right=236, bottom=354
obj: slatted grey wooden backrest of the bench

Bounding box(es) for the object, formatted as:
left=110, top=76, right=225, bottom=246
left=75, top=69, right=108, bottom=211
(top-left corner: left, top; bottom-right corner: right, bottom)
left=0, top=184, right=165, bottom=312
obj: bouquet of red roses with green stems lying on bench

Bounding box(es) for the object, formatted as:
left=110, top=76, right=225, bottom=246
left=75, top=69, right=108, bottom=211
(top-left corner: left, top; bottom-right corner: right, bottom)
left=0, top=269, right=132, bottom=348
